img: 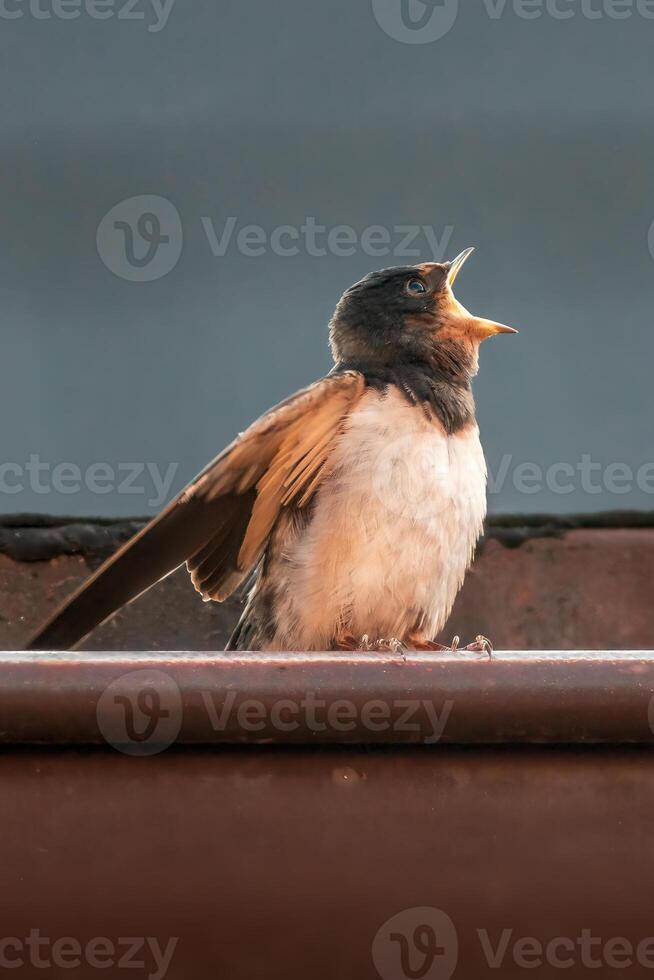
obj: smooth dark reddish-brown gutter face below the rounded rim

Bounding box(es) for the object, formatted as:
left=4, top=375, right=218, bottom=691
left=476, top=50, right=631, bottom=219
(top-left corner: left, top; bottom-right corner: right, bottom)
left=0, top=747, right=654, bottom=980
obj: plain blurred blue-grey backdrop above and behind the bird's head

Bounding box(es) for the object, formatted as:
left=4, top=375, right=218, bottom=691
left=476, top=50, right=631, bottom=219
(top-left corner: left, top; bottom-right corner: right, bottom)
left=0, top=0, right=654, bottom=516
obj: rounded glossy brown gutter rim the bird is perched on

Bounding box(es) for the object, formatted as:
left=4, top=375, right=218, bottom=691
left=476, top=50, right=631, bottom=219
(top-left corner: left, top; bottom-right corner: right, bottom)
left=0, top=651, right=654, bottom=755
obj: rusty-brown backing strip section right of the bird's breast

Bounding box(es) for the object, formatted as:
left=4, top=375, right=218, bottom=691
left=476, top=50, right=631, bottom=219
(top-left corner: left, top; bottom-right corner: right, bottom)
left=454, top=528, right=654, bottom=650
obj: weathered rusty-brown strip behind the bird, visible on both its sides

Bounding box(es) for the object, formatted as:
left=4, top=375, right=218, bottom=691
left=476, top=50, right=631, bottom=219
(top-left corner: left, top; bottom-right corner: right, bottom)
left=0, top=527, right=654, bottom=650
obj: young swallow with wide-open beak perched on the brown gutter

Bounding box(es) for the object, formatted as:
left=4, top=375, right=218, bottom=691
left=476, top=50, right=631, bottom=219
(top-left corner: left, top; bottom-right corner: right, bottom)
left=26, top=248, right=517, bottom=652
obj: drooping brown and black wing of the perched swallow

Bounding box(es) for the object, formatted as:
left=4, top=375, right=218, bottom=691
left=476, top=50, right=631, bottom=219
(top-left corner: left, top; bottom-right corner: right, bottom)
left=26, top=371, right=364, bottom=650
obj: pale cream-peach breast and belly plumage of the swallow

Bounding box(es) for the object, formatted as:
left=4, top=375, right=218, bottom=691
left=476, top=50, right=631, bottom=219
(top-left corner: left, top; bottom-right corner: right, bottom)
left=270, top=390, right=486, bottom=650
